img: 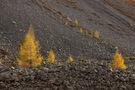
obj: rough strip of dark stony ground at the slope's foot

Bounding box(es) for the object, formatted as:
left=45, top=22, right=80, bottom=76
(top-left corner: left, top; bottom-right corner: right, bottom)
left=0, top=49, right=135, bottom=90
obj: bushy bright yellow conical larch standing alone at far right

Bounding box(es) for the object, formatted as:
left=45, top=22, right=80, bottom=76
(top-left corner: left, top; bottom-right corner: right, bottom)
left=111, top=49, right=127, bottom=69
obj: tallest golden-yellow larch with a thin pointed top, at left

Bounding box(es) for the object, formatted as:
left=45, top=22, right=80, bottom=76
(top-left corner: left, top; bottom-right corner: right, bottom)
left=17, top=25, right=43, bottom=67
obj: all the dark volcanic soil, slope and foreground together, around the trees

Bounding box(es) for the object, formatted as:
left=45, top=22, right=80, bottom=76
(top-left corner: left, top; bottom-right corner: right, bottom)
left=0, top=0, right=135, bottom=90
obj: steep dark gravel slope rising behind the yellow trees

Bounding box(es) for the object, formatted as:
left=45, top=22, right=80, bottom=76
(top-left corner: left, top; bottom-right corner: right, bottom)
left=0, top=0, right=135, bottom=59
